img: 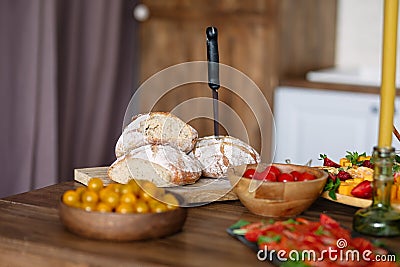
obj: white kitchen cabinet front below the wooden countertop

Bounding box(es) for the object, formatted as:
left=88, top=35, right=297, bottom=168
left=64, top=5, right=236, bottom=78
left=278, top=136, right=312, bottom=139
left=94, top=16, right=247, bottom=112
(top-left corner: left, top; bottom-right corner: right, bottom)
left=274, top=87, right=400, bottom=165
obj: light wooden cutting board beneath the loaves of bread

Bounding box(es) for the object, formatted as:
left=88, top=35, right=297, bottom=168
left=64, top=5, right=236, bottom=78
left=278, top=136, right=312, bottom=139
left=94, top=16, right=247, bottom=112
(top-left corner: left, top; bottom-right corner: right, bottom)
left=74, top=167, right=238, bottom=205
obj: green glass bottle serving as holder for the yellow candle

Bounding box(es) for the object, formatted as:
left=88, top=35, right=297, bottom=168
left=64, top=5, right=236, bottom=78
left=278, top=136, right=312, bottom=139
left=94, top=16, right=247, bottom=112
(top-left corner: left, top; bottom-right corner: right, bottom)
left=353, top=147, right=400, bottom=236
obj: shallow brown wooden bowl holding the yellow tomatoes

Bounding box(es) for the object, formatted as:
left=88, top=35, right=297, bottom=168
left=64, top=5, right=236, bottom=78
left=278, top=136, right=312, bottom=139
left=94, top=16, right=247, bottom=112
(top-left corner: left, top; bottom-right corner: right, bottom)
left=59, top=198, right=187, bottom=241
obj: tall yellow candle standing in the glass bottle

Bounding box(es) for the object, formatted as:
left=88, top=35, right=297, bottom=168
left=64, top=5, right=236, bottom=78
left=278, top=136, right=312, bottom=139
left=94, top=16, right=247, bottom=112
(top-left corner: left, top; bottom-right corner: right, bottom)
left=378, top=0, right=399, bottom=147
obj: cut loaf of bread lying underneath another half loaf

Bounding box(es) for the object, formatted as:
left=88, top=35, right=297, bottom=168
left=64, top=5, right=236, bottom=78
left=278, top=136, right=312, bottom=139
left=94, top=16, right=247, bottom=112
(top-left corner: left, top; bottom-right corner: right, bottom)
left=108, top=145, right=202, bottom=187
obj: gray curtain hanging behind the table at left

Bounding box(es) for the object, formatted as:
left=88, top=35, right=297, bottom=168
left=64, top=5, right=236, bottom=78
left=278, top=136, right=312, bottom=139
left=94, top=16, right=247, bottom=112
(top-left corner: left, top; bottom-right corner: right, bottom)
left=0, top=0, right=138, bottom=196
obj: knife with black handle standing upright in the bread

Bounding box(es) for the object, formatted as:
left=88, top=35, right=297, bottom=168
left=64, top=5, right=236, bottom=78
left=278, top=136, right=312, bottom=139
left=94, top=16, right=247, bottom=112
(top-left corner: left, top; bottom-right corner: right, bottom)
left=206, top=27, right=219, bottom=137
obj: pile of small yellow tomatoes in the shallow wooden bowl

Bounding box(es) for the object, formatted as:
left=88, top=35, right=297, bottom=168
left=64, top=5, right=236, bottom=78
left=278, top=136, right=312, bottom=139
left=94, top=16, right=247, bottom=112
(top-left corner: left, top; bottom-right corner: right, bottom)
left=62, top=178, right=179, bottom=214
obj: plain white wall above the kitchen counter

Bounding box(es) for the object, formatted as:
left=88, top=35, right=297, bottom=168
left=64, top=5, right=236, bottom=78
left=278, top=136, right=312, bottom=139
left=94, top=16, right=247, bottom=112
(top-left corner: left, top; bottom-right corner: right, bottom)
left=335, top=0, right=400, bottom=74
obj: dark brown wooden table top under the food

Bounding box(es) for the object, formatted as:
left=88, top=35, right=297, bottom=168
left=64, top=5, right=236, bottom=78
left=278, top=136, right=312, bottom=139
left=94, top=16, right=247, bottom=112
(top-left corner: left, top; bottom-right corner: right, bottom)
left=0, top=182, right=400, bottom=267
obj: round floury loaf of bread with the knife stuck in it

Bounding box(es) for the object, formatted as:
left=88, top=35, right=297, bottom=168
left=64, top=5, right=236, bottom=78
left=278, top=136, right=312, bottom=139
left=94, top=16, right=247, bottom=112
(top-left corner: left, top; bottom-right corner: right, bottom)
left=190, top=136, right=260, bottom=178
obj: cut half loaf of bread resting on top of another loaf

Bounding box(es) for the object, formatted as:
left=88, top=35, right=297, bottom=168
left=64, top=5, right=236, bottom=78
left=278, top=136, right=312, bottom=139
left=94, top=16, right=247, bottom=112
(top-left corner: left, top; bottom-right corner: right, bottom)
left=115, top=112, right=198, bottom=158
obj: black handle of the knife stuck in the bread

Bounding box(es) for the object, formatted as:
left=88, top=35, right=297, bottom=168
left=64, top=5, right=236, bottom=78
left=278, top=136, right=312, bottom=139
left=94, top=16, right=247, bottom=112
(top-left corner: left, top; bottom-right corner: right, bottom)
left=206, top=27, right=219, bottom=90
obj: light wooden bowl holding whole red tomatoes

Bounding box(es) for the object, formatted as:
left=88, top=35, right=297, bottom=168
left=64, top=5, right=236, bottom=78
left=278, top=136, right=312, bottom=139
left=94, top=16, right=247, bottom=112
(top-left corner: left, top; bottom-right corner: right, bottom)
left=228, top=163, right=328, bottom=217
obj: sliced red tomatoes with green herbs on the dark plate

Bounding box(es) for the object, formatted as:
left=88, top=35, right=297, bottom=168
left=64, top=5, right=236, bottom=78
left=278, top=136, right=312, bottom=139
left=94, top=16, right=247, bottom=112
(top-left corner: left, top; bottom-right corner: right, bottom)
left=244, top=214, right=397, bottom=267
